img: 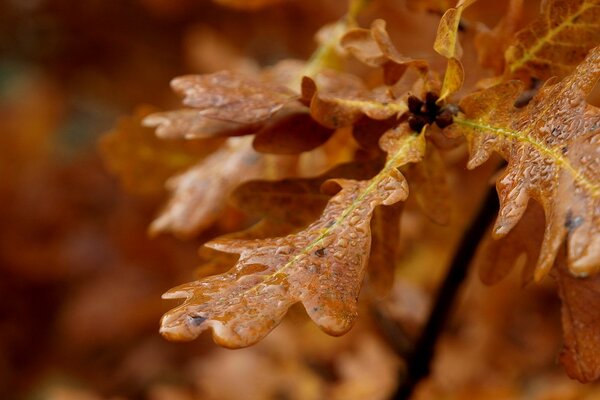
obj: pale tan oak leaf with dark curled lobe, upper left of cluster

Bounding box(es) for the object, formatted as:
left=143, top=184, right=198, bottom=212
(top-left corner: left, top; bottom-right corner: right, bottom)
left=143, top=60, right=333, bottom=154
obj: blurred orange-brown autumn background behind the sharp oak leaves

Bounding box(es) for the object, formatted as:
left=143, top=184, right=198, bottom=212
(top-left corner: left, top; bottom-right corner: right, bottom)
left=0, top=0, right=593, bottom=400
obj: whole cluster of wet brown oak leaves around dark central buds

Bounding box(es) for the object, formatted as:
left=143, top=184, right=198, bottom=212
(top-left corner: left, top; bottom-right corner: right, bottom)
left=104, top=0, right=600, bottom=390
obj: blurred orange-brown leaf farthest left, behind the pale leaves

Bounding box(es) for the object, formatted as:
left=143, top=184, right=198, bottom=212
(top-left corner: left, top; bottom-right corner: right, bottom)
left=100, top=107, right=214, bottom=194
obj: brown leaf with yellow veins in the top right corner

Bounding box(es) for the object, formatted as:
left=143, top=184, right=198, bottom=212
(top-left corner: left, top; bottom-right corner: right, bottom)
left=505, top=0, right=600, bottom=80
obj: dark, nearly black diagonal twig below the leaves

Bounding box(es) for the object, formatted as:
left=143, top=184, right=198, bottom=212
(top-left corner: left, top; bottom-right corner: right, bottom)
left=392, top=188, right=498, bottom=399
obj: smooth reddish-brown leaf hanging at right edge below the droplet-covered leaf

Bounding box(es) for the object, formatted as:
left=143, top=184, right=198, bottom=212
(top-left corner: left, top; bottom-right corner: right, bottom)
left=553, top=248, right=600, bottom=383
